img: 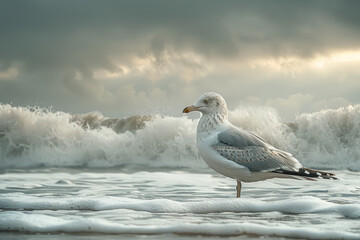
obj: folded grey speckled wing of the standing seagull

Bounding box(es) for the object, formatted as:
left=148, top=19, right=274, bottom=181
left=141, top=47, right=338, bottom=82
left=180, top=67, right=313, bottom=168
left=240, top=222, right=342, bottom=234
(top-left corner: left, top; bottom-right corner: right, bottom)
left=212, top=128, right=302, bottom=172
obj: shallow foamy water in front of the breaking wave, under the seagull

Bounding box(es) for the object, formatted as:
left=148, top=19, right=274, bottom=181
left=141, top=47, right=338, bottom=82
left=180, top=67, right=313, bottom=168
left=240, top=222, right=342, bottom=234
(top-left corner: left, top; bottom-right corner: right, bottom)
left=0, top=169, right=360, bottom=239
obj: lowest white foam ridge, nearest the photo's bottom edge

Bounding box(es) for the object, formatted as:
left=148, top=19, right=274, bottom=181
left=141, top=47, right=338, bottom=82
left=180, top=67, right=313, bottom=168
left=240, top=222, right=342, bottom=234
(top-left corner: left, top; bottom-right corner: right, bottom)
left=0, top=211, right=360, bottom=239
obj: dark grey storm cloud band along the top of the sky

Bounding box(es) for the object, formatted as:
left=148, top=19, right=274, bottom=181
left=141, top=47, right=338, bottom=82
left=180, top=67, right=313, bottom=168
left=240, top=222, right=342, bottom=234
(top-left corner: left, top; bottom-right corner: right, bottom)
left=0, top=0, right=360, bottom=68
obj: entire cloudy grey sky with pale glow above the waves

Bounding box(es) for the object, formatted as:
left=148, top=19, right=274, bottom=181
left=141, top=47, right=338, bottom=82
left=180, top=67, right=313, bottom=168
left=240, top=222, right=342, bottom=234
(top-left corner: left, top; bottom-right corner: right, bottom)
left=0, top=0, right=360, bottom=119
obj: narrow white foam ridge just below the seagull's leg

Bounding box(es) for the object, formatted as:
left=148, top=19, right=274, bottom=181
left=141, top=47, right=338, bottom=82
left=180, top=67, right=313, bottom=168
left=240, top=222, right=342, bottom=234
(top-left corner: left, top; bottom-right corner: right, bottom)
left=0, top=194, right=360, bottom=219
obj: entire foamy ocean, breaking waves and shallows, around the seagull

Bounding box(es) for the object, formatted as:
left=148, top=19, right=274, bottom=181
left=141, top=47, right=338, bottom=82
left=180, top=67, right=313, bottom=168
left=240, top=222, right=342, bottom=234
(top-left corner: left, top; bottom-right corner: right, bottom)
left=0, top=104, right=360, bottom=240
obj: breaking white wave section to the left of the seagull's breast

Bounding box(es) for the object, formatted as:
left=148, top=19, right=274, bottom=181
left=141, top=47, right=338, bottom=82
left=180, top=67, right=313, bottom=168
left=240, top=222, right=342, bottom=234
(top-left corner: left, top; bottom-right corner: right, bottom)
left=0, top=105, right=198, bottom=168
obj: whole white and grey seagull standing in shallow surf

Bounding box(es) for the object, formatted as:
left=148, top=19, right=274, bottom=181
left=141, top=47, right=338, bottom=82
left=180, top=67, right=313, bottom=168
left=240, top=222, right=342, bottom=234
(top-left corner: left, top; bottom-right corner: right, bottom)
left=183, top=92, right=337, bottom=198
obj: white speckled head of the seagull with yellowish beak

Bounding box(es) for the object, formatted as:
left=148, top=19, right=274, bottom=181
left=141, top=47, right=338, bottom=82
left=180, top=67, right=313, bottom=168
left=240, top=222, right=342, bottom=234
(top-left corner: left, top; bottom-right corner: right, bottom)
left=183, top=92, right=227, bottom=117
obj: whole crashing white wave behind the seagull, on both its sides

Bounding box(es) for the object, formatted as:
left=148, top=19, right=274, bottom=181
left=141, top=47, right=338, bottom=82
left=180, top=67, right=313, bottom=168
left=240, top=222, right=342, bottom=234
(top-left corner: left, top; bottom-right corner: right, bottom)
left=0, top=104, right=360, bottom=171
